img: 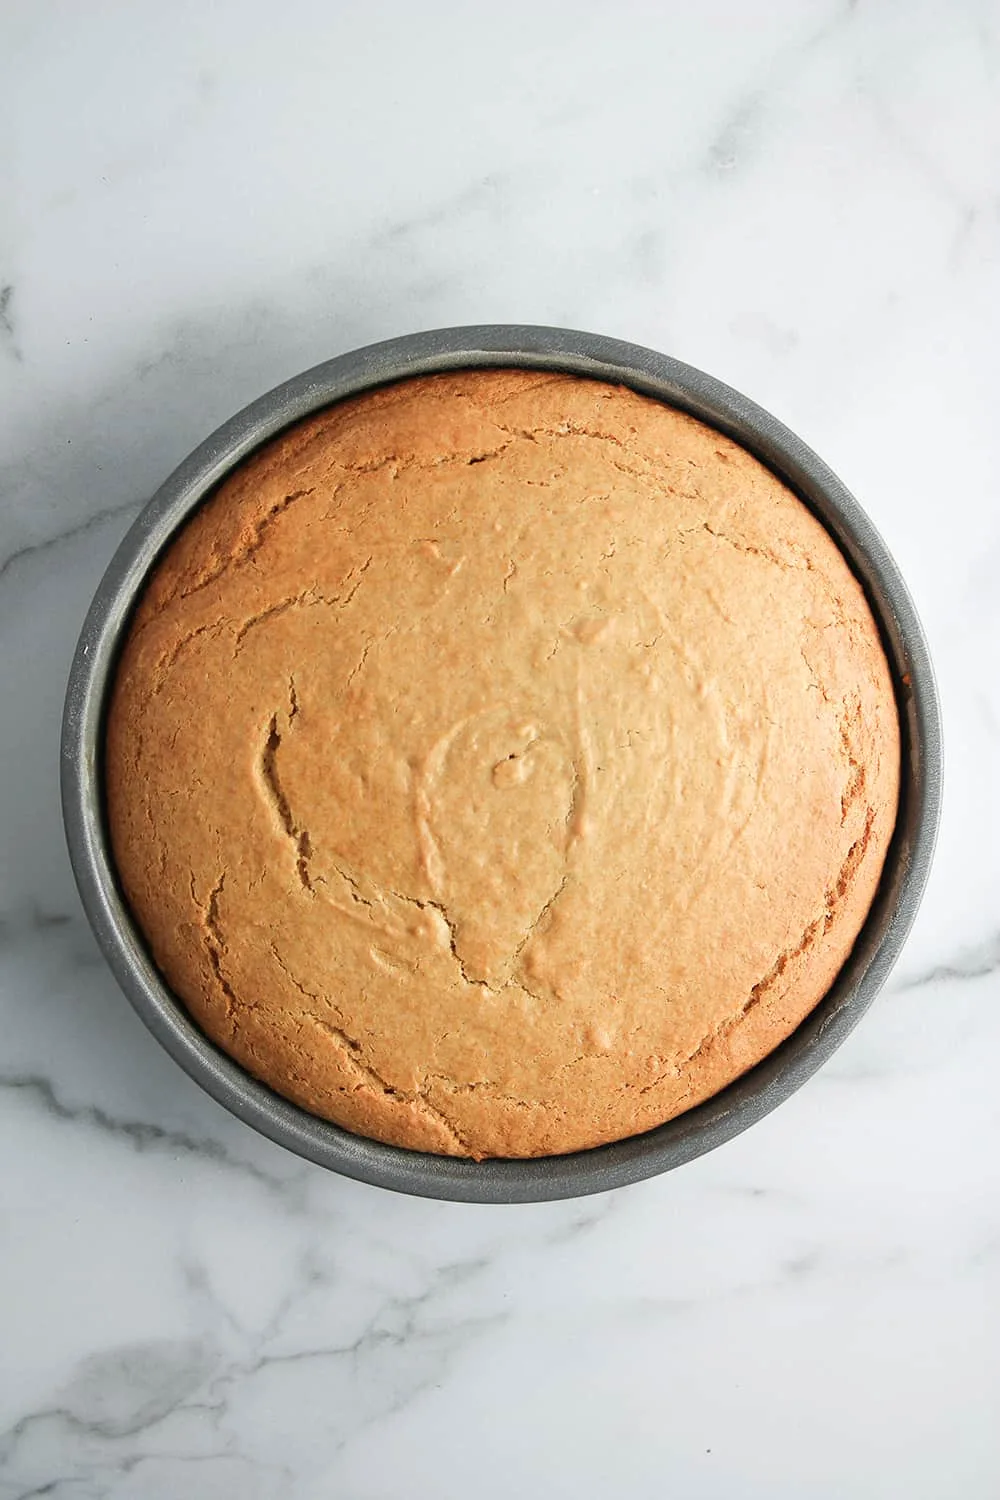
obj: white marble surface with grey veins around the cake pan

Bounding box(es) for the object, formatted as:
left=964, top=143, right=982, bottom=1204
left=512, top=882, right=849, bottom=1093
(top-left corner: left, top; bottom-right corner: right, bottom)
left=0, top=0, right=1000, bottom=1500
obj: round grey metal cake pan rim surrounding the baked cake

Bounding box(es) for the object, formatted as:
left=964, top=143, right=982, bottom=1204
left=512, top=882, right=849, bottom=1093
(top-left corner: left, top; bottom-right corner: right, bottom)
left=61, top=326, right=942, bottom=1203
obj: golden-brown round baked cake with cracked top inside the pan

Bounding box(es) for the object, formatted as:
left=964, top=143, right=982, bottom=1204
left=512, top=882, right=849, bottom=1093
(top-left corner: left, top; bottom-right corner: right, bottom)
left=106, top=371, right=900, bottom=1155
